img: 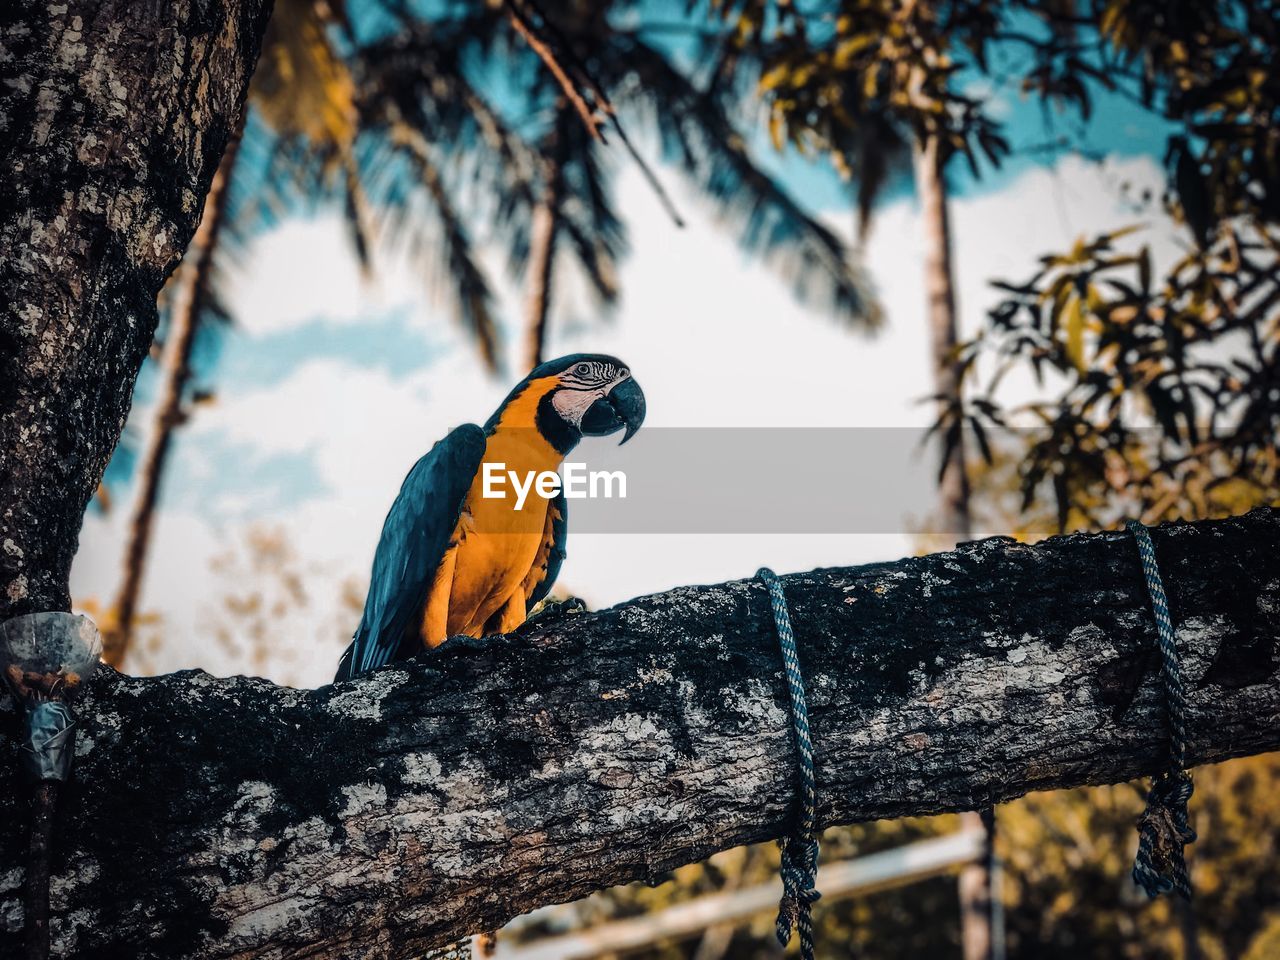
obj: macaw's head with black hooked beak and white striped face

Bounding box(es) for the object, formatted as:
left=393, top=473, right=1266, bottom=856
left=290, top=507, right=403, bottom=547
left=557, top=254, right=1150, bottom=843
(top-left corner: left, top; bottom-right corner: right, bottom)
left=489, top=353, right=645, bottom=453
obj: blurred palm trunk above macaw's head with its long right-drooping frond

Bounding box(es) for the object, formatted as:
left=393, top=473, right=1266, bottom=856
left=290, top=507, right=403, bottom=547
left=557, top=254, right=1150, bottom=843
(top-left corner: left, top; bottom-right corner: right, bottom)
left=496, top=3, right=879, bottom=364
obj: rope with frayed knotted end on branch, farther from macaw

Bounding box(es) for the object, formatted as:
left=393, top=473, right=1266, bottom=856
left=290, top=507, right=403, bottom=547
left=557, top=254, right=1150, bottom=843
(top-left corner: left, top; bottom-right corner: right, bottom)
left=1125, top=520, right=1196, bottom=900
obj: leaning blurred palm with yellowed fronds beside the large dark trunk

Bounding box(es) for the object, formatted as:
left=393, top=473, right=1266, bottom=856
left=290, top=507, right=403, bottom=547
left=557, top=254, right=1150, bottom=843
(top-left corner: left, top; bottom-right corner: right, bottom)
left=104, top=0, right=520, bottom=667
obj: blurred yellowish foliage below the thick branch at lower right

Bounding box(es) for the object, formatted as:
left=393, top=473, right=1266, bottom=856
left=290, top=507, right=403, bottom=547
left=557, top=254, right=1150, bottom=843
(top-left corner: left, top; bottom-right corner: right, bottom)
left=521, top=755, right=1280, bottom=960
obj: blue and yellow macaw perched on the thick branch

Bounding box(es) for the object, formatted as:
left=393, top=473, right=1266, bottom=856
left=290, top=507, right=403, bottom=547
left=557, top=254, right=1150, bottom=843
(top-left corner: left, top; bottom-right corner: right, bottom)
left=335, top=353, right=645, bottom=680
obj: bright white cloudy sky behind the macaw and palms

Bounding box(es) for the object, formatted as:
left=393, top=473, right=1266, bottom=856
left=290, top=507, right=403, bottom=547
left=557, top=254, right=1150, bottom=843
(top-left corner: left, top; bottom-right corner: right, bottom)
left=72, top=157, right=1175, bottom=685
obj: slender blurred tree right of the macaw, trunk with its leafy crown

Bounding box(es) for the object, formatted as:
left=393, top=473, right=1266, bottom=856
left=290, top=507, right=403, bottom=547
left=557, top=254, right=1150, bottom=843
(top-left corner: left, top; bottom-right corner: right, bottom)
left=732, top=0, right=1009, bottom=539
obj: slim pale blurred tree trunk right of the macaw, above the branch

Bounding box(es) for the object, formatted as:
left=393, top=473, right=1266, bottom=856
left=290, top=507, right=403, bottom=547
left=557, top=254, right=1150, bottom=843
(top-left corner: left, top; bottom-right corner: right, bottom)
left=914, top=136, right=973, bottom=539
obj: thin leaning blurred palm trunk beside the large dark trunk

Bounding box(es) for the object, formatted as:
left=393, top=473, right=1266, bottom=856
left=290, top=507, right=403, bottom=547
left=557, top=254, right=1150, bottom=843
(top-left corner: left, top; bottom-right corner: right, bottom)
left=102, top=131, right=241, bottom=668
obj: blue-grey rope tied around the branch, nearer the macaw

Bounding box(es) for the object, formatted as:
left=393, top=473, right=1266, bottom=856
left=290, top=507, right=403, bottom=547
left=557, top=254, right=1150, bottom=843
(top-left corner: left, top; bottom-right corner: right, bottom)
left=756, top=567, right=820, bottom=960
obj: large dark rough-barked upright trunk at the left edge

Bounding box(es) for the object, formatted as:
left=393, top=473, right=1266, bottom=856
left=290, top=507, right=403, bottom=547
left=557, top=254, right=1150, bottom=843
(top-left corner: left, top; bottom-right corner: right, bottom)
left=0, top=0, right=270, bottom=620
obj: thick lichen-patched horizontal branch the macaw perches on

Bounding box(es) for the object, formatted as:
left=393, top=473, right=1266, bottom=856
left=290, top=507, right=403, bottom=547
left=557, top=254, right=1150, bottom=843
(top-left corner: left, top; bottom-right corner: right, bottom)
left=0, top=511, right=1280, bottom=957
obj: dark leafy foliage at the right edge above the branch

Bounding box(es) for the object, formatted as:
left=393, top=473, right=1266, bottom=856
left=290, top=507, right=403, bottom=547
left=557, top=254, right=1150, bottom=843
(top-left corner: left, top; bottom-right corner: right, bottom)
left=921, top=0, right=1280, bottom=530
